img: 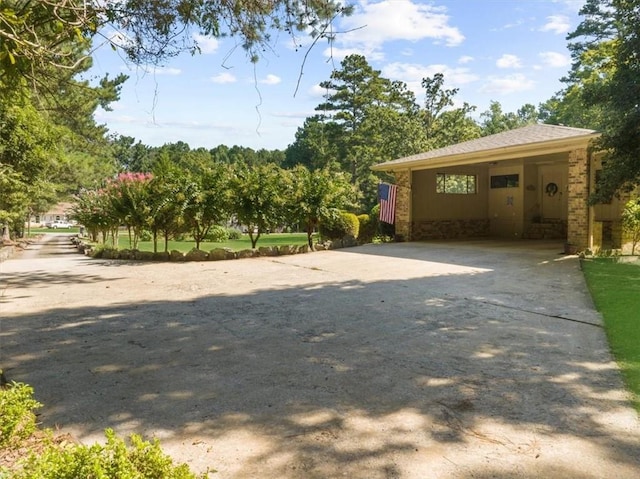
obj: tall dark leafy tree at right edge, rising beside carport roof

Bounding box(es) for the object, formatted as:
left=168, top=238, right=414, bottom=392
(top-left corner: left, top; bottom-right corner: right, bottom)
left=568, top=0, right=640, bottom=202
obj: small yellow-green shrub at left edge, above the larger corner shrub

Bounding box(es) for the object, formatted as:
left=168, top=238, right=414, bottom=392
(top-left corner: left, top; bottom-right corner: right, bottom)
left=0, top=382, right=42, bottom=446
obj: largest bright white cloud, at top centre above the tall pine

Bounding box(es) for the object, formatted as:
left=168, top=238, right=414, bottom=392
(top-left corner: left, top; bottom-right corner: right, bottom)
left=325, top=0, right=465, bottom=59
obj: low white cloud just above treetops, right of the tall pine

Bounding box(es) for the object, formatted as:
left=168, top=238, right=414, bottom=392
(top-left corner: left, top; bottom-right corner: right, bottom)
left=382, top=62, right=478, bottom=97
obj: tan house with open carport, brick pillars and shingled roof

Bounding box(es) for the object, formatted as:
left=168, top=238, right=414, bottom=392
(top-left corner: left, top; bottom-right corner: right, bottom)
left=373, top=124, right=630, bottom=252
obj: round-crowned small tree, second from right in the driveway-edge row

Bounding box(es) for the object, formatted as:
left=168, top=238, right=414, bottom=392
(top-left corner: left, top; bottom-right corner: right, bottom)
left=230, top=163, right=293, bottom=248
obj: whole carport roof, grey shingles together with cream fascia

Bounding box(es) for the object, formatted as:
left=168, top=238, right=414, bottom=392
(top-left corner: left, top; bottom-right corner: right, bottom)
left=373, top=124, right=599, bottom=171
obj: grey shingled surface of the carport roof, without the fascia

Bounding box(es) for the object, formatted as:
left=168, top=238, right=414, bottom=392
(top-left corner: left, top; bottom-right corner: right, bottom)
left=376, top=124, right=596, bottom=169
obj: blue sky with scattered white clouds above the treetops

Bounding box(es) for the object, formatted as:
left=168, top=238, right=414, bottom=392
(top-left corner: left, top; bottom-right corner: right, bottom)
left=92, top=0, right=583, bottom=149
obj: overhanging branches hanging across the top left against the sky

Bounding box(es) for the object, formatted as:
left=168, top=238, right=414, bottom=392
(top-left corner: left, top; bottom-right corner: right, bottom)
left=0, top=0, right=351, bottom=92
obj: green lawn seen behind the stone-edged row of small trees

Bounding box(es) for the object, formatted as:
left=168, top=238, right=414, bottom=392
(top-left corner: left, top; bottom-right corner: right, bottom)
left=118, top=233, right=314, bottom=253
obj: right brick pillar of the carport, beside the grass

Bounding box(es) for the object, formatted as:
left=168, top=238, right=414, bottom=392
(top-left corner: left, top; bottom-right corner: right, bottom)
left=567, top=148, right=589, bottom=251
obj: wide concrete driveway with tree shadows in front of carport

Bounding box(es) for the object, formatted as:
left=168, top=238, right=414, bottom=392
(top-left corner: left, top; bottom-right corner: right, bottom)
left=0, top=236, right=640, bottom=479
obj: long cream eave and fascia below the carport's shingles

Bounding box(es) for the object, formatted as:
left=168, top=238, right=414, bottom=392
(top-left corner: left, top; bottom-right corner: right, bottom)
left=371, top=132, right=600, bottom=171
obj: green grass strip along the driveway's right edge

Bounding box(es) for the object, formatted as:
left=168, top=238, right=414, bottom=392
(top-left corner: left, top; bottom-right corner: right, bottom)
left=582, top=258, right=640, bottom=412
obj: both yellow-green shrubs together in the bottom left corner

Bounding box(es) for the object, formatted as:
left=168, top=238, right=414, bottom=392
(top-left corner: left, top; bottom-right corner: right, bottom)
left=0, top=382, right=208, bottom=479
